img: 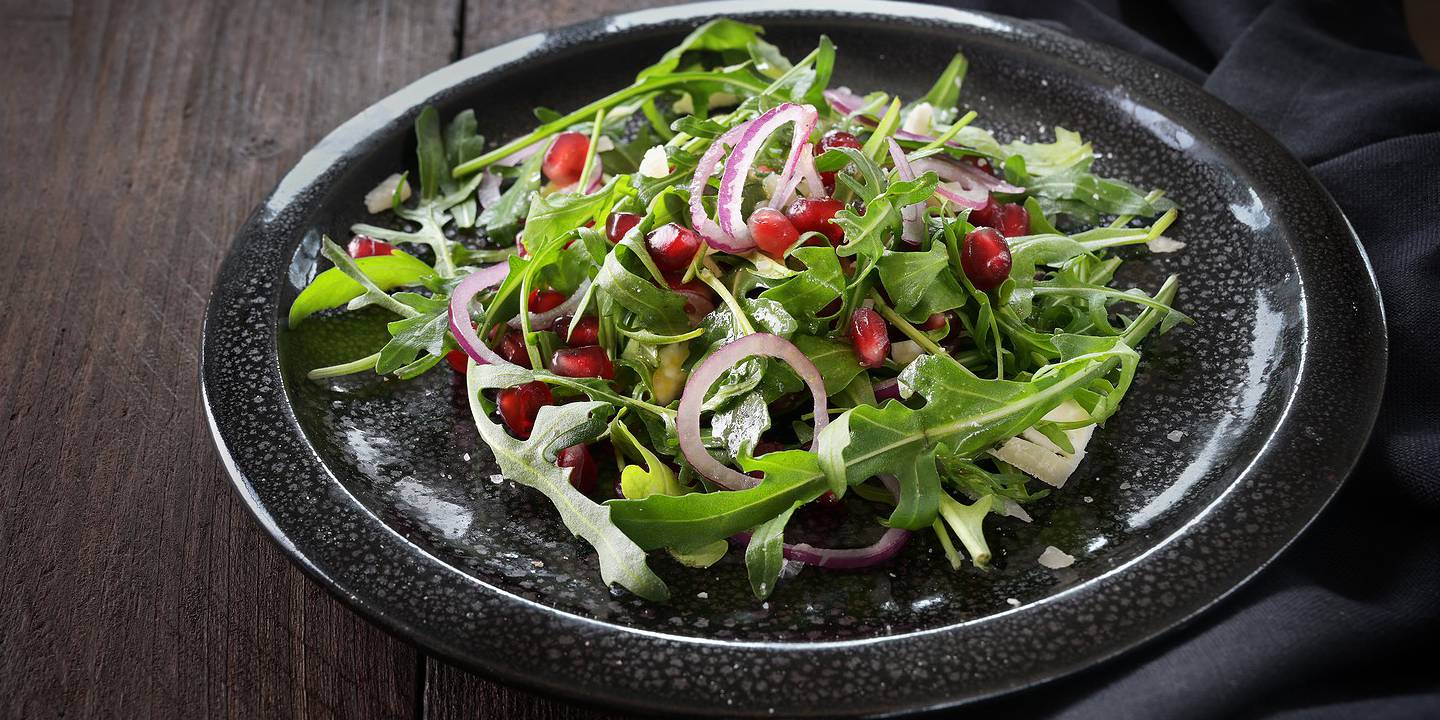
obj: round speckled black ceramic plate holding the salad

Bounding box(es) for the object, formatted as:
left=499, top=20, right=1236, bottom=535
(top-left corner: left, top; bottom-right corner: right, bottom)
left=203, top=1, right=1385, bottom=716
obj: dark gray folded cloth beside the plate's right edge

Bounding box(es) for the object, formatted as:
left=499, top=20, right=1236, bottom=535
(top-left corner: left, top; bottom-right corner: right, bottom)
left=927, top=0, right=1440, bottom=719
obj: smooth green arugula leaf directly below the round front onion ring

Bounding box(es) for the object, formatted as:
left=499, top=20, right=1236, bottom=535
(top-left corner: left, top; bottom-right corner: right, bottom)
left=607, top=449, right=829, bottom=550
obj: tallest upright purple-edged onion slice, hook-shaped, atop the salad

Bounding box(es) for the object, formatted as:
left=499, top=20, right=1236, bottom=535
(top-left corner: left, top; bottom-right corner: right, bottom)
left=711, top=102, right=819, bottom=252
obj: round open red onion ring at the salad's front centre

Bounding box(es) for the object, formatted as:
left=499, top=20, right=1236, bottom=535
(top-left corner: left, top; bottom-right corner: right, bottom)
left=675, top=333, right=829, bottom=490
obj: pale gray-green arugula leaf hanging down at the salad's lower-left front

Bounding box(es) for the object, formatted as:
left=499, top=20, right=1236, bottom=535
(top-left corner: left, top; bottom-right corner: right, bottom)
left=467, top=364, right=670, bottom=600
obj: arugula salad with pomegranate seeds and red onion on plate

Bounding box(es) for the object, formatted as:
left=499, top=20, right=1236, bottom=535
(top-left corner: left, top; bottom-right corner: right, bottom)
left=289, top=20, right=1188, bottom=600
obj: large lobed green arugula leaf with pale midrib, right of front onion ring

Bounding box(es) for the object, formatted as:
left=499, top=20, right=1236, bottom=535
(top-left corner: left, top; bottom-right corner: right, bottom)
left=819, top=336, right=1139, bottom=530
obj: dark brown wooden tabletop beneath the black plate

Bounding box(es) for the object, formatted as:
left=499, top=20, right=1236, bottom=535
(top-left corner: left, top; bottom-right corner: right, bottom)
left=0, top=0, right=1440, bottom=720
